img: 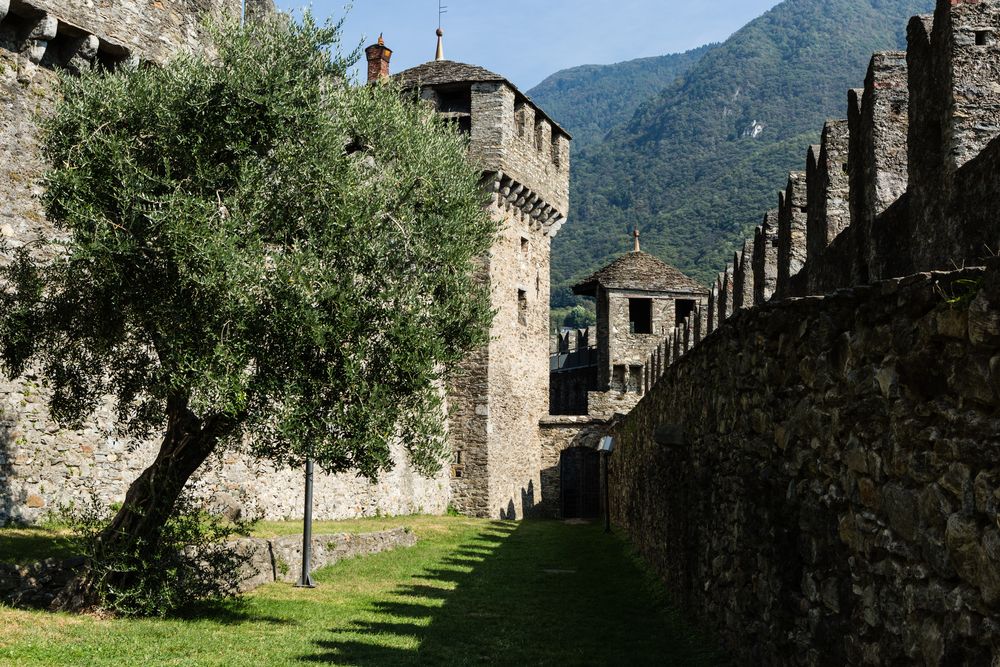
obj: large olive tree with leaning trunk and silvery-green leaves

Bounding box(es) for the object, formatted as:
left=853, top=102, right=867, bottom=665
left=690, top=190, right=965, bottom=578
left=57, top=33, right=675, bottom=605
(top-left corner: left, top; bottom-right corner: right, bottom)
left=0, top=14, right=497, bottom=580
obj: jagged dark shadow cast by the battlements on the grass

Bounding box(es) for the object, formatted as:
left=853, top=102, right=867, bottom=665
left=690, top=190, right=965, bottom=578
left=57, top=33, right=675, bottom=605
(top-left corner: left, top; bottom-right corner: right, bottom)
left=301, top=521, right=726, bottom=667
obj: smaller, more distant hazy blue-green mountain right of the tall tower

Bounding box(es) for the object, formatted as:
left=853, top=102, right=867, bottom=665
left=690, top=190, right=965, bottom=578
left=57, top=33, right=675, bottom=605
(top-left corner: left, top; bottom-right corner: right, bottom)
left=528, top=45, right=714, bottom=151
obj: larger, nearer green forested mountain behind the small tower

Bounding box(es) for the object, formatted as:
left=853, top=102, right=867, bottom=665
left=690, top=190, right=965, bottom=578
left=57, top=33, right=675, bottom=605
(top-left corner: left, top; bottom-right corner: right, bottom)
left=552, top=0, right=934, bottom=306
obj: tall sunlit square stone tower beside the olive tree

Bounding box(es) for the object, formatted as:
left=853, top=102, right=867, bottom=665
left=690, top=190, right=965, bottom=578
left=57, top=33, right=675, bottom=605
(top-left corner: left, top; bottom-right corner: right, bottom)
left=394, top=50, right=570, bottom=519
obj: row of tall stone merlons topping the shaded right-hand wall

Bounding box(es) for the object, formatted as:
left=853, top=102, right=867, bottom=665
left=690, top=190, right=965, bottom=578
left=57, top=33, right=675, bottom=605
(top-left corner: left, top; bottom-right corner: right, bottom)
left=648, top=0, right=1000, bottom=392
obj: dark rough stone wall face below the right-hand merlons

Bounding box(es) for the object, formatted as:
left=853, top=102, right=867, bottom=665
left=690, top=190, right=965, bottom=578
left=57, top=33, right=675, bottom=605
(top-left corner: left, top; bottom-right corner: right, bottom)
left=610, top=262, right=1000, bottom=665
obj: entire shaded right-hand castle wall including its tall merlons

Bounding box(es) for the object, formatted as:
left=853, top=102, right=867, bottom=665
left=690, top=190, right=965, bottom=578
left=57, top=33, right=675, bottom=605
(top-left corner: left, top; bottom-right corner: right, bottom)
left=611, top=0, right=1000, bottom=665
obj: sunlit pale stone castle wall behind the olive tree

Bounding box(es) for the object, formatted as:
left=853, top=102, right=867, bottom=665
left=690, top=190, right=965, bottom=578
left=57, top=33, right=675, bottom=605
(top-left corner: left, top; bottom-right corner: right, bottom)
left=0, top=0, right=448, bottom=524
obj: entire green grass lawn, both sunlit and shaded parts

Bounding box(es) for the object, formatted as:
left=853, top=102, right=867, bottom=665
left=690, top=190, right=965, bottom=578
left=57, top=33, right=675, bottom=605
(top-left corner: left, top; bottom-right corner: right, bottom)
left=0, top=517, right=722, bottom=667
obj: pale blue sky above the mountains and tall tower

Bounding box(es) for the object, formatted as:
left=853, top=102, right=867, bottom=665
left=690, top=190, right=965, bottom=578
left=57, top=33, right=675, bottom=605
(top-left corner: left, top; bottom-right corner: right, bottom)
left=278, top=0, right=778, bottom=90
